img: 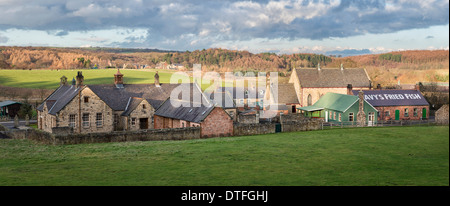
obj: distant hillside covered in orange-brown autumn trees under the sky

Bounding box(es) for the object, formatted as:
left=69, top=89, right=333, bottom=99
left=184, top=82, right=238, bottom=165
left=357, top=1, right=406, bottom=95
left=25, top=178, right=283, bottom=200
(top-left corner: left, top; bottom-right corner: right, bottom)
left=0, top=47, right=449, bottom=85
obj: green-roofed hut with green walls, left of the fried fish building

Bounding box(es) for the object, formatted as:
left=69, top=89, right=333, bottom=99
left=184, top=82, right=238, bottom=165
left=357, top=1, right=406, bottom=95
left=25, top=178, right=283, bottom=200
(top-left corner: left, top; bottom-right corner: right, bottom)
left=298, top=92, right=378, bottom=126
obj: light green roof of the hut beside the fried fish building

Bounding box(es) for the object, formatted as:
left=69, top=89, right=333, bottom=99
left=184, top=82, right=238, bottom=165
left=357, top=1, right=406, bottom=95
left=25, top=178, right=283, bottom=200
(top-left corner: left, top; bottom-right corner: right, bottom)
left=299, top=92, right=358, bottom=112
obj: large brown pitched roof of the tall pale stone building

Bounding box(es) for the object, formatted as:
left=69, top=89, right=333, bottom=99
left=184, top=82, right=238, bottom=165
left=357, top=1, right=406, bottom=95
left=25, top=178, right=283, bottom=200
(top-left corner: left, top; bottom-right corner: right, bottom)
left=296, top=68, right=370, bottom=88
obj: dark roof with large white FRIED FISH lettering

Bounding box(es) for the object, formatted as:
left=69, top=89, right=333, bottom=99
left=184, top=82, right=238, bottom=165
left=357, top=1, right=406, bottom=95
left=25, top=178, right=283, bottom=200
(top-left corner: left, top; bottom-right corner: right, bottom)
left=352, top=90, right=429, bottom=107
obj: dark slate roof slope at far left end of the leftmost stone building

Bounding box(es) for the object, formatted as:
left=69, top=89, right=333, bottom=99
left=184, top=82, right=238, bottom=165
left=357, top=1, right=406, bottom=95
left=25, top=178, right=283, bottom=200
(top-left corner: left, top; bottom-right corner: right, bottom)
left=36, top=85, right=83, bottom=115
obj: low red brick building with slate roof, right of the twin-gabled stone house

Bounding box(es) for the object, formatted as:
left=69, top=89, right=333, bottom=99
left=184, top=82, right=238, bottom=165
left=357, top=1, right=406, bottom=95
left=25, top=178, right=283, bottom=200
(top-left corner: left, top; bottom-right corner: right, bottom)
left=154, top=84, right=233, bottom=138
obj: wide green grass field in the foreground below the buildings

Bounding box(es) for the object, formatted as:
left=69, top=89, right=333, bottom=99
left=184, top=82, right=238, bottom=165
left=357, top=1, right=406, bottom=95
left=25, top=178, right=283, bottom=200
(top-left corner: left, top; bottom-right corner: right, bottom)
left=0, top=126, right=449, bottom=186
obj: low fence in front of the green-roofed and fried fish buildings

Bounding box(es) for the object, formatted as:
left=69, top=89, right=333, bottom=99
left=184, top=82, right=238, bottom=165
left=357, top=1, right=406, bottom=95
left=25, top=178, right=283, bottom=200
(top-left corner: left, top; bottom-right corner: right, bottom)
left=321, top=119, right=435, bottom=129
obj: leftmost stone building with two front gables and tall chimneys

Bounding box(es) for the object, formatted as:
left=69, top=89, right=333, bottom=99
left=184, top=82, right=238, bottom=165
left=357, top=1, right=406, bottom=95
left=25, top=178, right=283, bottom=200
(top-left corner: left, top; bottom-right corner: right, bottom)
left=37, top=70, right=181, bottom=133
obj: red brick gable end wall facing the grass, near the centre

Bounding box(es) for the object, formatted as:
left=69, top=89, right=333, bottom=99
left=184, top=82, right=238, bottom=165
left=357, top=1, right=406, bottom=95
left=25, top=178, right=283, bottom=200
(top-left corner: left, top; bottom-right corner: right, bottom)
left=201, top=107, right=233, bottom=138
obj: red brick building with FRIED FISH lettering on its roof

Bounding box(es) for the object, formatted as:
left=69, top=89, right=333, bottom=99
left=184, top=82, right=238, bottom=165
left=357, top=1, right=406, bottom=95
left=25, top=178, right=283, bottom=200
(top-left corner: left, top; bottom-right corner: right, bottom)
left=352, top=89, right=430, bottom=121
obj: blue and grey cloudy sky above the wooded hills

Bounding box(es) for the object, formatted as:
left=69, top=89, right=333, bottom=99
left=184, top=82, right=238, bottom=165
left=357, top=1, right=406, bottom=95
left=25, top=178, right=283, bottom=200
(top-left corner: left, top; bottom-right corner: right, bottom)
left=0, top=0, right=449, bottom=53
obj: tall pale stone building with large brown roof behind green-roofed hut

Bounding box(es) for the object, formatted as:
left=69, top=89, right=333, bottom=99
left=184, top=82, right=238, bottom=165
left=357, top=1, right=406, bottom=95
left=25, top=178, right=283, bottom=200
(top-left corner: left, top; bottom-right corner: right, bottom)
left=289, top=65, right=372, bottom=107
